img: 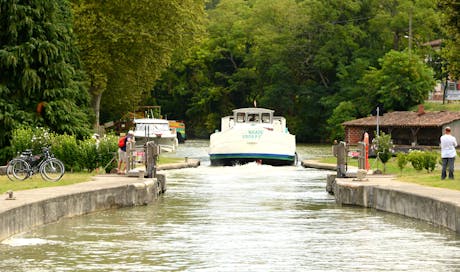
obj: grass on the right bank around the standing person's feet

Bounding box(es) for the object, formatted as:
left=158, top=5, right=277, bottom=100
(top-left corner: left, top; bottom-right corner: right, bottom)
left=319, top=157, right=460, bottom=190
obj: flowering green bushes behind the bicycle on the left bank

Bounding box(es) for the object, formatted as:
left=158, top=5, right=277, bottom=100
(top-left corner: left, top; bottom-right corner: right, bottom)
left=10, top=127, right=118, bottom=172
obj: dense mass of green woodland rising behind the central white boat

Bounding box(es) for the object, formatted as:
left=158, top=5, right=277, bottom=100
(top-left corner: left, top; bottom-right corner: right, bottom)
left=155, top=0, right=442, bottom=142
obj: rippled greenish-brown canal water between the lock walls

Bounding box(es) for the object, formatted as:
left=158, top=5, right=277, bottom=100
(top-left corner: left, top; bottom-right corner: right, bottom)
left=0, top=141, right=460, bottom=271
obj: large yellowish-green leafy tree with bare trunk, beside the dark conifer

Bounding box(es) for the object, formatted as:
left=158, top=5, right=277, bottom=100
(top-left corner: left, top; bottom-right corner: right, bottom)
left=72, top=0, right=204, bottom=130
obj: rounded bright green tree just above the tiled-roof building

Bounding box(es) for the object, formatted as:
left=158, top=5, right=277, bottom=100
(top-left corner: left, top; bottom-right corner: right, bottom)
left=360, top=50, right=435, bottom=110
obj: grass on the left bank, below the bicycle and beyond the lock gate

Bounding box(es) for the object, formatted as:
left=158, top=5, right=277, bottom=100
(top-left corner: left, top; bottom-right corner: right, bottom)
left=0, top=157, right=184, bottom=193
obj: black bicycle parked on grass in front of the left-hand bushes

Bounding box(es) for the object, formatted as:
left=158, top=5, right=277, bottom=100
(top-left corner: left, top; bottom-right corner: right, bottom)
left=6, top=147, right=65, bottom=181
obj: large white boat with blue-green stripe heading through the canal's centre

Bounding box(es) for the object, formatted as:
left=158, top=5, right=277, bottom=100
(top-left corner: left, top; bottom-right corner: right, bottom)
left=209, top=108, right=297, bottom=166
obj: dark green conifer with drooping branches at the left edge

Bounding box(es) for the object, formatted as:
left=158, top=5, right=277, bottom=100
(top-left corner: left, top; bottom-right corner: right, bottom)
left=0, top=0, right=89, bottom=161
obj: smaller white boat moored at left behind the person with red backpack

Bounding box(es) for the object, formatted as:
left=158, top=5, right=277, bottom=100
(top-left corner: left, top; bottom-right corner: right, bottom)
left=134, top=118, right=178, bottom=152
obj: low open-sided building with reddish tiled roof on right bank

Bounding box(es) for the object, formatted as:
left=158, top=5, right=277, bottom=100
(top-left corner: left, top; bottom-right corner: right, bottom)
left=342, top=106, right=460, bottom=146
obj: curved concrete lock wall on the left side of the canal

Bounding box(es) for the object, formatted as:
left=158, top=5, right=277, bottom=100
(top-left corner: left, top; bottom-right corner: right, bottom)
left=0, top=175, right=166, bottom=241
